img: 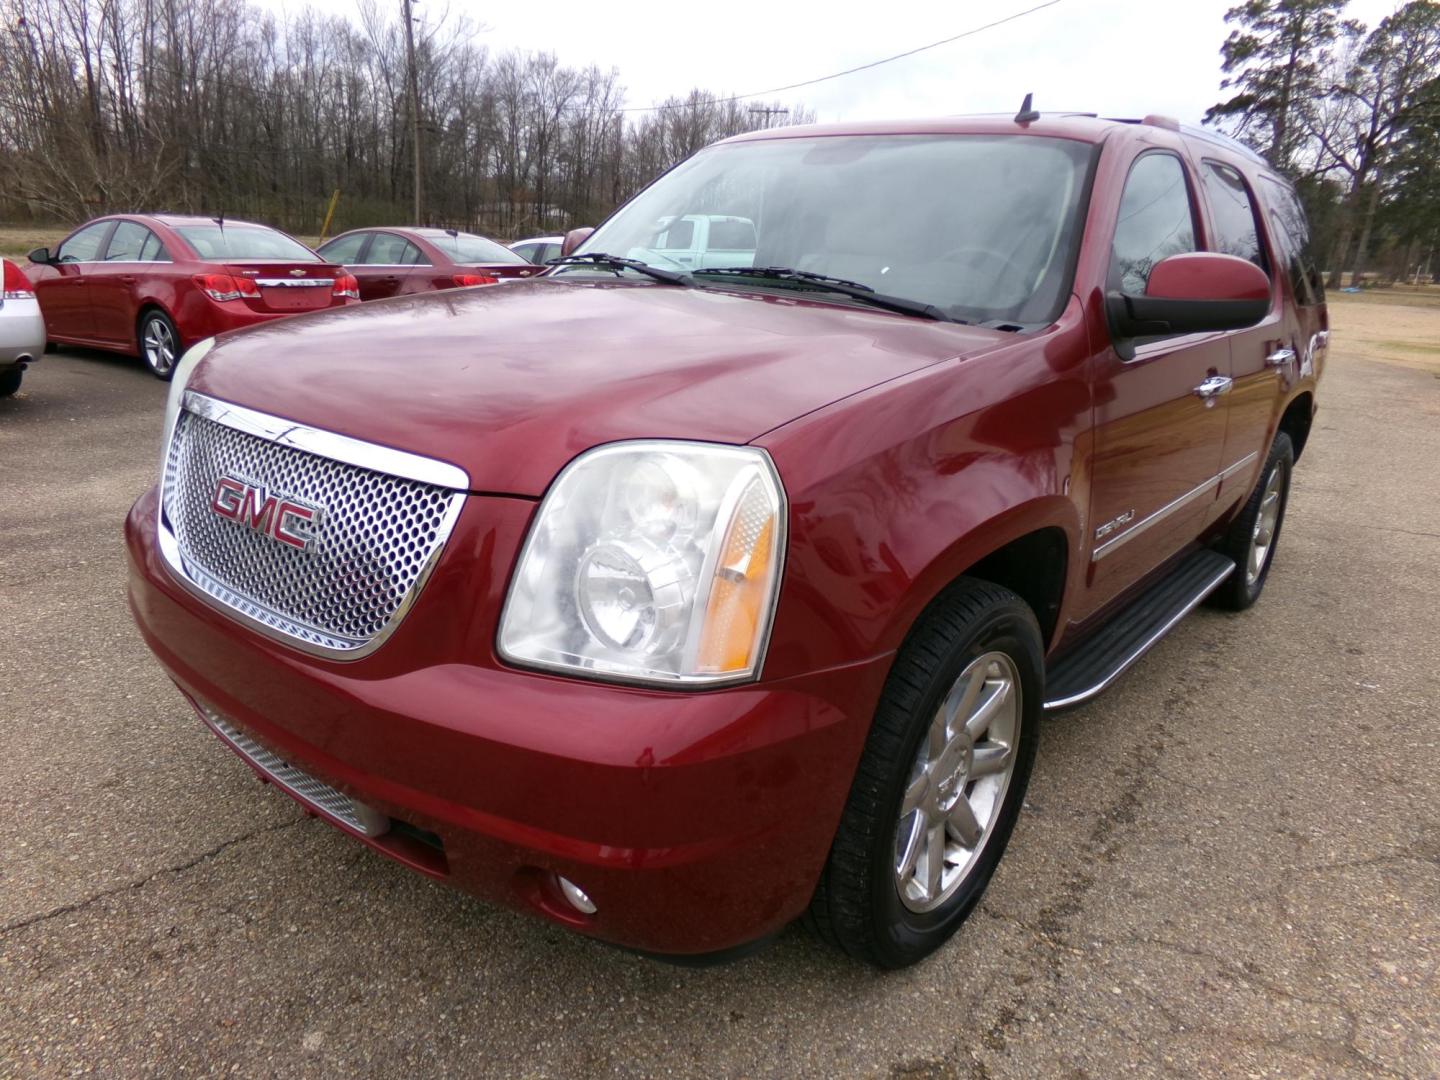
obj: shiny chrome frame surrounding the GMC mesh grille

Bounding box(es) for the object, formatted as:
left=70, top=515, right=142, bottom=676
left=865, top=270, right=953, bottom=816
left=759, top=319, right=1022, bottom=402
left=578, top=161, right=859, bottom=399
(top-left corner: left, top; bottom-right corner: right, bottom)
left=156, top=390, right=469, bottom=662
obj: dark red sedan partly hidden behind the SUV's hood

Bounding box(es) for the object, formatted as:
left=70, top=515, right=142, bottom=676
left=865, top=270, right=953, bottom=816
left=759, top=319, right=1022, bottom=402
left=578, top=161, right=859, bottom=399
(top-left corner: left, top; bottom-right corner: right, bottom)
left=320, top=229, right=544, bottom=300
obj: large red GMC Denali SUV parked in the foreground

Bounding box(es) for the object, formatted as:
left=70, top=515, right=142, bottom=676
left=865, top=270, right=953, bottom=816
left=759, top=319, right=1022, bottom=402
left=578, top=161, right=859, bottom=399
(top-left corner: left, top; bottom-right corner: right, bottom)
left=127, top=111, right=1328, bottom=968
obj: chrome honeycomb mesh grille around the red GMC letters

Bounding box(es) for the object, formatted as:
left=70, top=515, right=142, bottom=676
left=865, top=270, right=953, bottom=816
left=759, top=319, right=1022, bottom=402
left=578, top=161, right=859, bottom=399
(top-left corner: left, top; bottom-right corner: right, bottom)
left=161, top=395, right=464, bottom=658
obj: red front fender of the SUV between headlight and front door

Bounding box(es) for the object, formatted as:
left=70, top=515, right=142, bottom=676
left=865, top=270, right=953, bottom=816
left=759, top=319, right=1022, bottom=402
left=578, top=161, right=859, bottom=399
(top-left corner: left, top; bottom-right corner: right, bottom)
left=760, top=315, right=1090, bottom=678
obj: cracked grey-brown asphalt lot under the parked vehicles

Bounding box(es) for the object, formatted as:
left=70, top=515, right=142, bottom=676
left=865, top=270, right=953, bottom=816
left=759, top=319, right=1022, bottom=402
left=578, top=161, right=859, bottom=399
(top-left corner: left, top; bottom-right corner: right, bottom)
left=0, top=301, right=1440, bottom=1080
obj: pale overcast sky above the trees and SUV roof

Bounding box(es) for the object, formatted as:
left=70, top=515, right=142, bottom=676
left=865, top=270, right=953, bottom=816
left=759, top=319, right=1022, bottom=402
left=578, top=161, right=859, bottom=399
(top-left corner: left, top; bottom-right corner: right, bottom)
left=261, top=0, right=1397, bottom=122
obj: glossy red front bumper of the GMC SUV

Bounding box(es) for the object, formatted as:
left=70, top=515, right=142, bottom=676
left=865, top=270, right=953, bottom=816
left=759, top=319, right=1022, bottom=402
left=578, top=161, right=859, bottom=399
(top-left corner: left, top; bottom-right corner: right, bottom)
left=125, top=490, right=890, bottom=955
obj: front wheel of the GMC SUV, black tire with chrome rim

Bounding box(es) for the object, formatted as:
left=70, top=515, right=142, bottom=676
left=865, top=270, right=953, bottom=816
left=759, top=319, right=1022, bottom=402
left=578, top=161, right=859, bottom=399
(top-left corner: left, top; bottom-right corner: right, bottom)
left=806, top=577, right=1044, bottom=968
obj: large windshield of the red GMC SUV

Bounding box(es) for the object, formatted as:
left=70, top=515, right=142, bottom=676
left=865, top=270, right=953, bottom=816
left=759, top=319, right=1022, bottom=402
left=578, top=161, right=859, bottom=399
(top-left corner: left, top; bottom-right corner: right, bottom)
left=563, top=135, right=1093, bottom=325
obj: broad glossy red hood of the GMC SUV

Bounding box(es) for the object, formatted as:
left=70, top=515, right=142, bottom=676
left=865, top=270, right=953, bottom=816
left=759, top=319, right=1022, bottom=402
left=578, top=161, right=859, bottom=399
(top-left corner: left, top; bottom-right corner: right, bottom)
left=190, top=278, right=1014, bottom=497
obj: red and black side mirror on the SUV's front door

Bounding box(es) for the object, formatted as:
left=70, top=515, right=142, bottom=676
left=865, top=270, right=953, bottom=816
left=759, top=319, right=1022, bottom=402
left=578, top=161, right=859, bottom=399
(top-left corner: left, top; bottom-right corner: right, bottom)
left=1104, top=251, right=1270, bottom=360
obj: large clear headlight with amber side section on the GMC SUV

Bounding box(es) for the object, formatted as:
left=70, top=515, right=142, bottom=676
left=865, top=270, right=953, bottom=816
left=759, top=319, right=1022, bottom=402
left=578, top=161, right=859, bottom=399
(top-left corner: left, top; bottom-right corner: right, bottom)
left=500, top=442, right=785, bottom=685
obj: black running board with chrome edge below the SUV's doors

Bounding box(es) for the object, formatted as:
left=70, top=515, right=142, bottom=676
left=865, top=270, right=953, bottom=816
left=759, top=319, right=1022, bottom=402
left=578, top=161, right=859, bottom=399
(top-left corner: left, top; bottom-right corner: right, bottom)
left=1045, top=550, right=1236, bottom=711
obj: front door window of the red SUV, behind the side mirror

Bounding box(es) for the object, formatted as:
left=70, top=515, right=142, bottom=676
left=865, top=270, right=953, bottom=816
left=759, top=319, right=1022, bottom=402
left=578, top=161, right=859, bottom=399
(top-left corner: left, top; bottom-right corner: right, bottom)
left=1109, top=153, right=1195, bottom=297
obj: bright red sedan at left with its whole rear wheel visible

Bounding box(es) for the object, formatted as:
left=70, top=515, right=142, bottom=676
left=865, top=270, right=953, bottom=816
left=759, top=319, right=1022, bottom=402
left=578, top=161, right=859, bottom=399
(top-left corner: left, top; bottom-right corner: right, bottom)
left=26, top=215, right=360, bottom=379
